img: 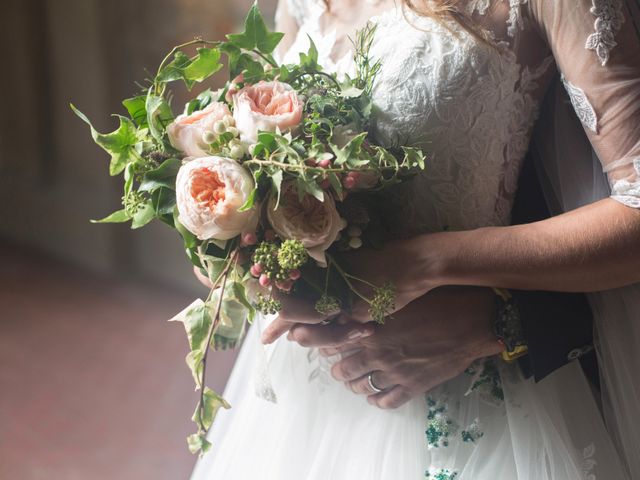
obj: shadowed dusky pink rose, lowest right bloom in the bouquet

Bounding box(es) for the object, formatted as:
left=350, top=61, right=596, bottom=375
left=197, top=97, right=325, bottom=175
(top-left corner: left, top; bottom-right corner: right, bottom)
left=267, top=182, right=347, bottom=266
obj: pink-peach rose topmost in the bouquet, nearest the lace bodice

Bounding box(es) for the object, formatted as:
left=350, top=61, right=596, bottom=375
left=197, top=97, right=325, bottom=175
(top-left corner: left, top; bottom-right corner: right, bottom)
left=233, top=81, right=303, bottom=143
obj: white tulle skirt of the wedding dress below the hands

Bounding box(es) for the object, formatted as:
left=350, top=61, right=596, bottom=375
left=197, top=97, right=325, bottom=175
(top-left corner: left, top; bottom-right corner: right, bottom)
left=191, top=319, right=628, bottom=480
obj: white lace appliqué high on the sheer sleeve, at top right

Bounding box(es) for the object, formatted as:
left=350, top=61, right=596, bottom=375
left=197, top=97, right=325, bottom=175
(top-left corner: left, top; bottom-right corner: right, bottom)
left=585, top=0, right=624, bottom=67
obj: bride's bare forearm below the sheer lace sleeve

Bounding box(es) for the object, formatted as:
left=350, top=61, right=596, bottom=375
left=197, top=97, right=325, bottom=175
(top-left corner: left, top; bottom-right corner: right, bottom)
left=410, top=199, right=640, bottom=292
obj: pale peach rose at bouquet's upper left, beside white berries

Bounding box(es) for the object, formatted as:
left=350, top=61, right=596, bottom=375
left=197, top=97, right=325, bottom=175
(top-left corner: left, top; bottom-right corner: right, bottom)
left=167, top=102, right=231, bottom=157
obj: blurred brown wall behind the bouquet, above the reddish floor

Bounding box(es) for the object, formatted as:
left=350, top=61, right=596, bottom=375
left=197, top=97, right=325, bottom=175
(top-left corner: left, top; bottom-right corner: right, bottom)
left=0, top=0, right=275, bottom=287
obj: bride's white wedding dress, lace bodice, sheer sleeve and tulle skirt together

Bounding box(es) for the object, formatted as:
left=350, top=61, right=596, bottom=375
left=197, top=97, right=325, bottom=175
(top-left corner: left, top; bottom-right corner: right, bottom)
left=192, top=0, right=640, bottom=480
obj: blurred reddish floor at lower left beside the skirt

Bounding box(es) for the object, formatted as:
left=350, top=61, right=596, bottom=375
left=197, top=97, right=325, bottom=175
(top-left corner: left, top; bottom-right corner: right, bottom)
left=0, top=246, right=234, bottom=480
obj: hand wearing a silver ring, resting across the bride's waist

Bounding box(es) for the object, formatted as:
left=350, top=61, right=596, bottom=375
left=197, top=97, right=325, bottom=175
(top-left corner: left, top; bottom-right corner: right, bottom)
left=289, top=287, right=502, bottom=408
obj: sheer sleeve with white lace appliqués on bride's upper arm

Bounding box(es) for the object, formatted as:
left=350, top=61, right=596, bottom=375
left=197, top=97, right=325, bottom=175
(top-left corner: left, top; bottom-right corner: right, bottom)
left=529, top=0, right=640, bottom=208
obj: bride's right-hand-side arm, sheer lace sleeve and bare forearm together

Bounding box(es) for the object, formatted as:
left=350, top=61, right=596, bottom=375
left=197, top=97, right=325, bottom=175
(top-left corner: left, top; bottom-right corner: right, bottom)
left=424, top=0, right=640, bottom=291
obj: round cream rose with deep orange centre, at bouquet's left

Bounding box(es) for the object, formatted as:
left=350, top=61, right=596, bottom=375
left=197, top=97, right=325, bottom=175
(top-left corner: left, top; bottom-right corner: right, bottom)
left=176, top=157, right=258, bottom=240
